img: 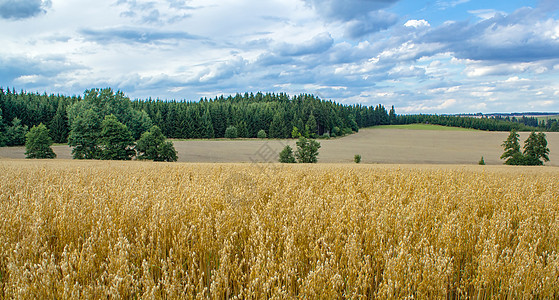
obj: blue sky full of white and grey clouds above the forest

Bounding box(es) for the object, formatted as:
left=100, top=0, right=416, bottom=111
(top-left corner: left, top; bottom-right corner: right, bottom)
left=0, top=0, right=559, bottom=114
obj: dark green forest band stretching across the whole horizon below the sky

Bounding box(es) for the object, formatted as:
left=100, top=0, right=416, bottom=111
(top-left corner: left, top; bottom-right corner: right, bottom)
left=0, top=88, right=559, bottom=146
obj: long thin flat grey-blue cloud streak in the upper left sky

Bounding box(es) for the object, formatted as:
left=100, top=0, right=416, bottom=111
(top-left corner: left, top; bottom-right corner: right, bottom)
left=79, top=27, right=204, bottom=44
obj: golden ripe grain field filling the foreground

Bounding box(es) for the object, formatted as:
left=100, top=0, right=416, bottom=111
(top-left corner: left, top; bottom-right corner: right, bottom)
left=0, top=160, right=559, bottom=299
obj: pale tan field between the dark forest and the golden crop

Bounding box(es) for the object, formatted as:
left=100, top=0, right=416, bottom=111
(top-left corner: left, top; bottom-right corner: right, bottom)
left=0, top=125, right=559, bottom=166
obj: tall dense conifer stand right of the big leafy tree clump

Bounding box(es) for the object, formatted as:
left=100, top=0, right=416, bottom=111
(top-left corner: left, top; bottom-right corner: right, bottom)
left=132, top=93, right=395, bottom=139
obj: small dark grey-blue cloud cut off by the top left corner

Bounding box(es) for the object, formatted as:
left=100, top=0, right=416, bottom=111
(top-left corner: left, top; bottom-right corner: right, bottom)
left=0, top=0, right=51, bottom=20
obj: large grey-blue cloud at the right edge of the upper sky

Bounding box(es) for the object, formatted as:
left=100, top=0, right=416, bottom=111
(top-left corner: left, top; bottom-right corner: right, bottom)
left=424, top=8, right=559, bottom=62
